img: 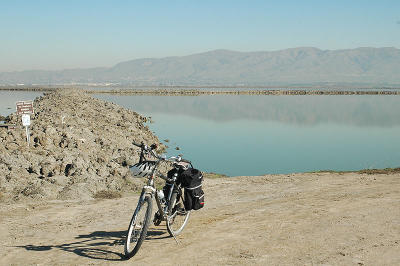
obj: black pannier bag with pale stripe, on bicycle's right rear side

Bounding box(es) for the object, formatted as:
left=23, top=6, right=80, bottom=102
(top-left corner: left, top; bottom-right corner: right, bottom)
left=180, top=168, right=204, bottom=210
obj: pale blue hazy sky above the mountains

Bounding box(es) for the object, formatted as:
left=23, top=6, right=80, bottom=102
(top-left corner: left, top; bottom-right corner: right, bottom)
left=0, top=0, right=400, bottom=71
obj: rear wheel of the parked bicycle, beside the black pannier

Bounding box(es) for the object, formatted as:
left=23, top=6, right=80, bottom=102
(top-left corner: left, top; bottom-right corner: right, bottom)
left=167, top=192, right=190, bottom=236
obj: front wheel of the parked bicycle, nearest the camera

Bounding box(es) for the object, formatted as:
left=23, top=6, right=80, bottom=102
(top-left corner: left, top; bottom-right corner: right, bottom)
left=124, top=196, right=153, bottom=259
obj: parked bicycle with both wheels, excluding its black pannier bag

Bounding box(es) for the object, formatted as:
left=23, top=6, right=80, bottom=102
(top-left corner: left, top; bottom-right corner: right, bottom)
left=124, top=143, right=193, bottom=259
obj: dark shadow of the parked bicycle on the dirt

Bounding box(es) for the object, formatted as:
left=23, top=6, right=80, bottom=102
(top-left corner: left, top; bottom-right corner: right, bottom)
left=16, top=228, right=170, bottom=261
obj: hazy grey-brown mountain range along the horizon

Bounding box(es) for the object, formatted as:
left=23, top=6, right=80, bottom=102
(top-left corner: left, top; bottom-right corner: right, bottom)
left=0, top=47, right=400, bottom=87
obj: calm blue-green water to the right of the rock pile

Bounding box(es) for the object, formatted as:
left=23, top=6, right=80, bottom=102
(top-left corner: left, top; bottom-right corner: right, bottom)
left=96, top=95, right=400, bottom=176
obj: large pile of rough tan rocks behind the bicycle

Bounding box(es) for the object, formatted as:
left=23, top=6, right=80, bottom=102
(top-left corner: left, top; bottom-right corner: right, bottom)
left=0, top=90, right=164, bottom=201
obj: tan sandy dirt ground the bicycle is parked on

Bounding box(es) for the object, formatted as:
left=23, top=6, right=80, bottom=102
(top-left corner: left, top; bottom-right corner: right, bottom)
left=0, top=173, right=400, bottom=265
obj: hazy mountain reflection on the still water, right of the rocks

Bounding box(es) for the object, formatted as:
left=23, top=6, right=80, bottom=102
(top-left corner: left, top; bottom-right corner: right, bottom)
left=96, top=95, right=400, bottom=127
